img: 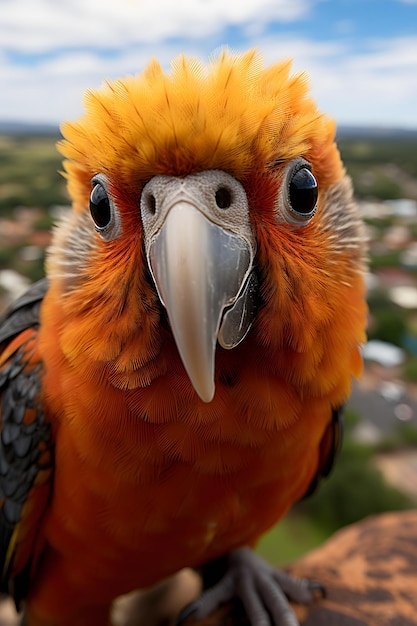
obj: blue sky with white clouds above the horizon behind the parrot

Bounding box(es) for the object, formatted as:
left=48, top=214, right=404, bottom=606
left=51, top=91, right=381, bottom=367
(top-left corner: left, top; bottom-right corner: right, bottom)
left=0, top=0, right=417, bottom=128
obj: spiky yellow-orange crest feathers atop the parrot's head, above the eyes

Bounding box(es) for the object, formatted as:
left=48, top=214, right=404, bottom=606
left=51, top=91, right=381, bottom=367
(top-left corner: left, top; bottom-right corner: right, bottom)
left=59, top=50, right=341, bottom=210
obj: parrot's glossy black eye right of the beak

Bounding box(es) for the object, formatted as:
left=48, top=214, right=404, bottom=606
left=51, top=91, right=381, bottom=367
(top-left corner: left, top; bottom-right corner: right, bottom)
left=280, top=158, right=318, bottom=225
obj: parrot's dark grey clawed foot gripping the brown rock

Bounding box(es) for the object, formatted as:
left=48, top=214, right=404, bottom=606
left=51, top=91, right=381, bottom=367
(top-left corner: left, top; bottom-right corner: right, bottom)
left=177, top=548, right=325, bottom=626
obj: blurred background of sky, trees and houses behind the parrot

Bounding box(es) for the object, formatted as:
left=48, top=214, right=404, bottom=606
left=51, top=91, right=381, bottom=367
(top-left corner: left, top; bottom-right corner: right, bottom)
left=0, top=0, right=417, bottom=563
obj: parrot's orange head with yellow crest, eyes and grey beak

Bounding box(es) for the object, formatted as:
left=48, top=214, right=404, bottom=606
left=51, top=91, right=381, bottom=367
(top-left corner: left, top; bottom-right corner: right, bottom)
left=47, top=51, right=364, bottom=402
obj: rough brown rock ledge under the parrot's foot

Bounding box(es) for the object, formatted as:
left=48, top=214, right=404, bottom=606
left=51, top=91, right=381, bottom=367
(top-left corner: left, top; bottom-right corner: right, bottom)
left=173, top=511, right=417, bottom=626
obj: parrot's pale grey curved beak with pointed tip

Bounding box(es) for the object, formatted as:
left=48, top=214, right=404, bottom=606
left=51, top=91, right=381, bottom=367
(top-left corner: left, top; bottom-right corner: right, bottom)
left=148, top=201, right=253, bottom=402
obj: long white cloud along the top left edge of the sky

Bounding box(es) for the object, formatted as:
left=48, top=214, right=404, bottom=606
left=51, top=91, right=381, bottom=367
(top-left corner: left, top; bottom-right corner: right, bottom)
left=0, top=0, right=312, bottom=53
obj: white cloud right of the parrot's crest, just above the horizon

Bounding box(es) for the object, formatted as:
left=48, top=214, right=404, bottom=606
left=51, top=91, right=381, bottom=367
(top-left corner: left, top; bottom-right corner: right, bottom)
left=244, top=36, right=417, bottom=128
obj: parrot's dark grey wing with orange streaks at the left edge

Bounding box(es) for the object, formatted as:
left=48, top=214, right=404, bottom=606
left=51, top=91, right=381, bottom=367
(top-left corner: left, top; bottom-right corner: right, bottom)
left=0, top=280, right=52, bottom=604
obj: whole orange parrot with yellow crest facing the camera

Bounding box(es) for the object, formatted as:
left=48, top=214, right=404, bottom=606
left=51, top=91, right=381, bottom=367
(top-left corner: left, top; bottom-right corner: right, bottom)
left=0, top=49, right=367, bottom=626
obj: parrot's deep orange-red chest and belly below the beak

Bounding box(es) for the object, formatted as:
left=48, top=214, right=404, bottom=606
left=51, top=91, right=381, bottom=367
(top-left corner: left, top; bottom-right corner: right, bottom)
left=45, top=364, right=322, bottom=593
